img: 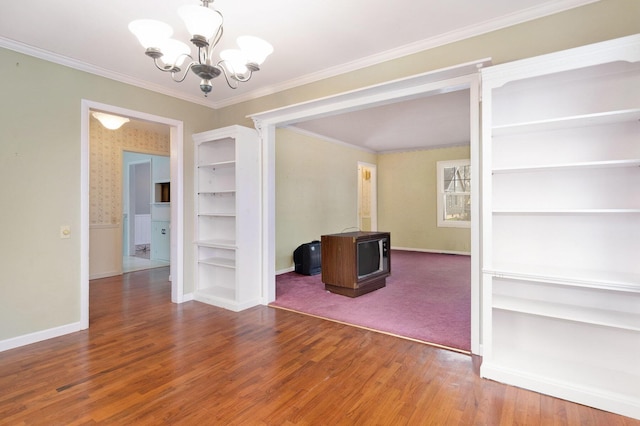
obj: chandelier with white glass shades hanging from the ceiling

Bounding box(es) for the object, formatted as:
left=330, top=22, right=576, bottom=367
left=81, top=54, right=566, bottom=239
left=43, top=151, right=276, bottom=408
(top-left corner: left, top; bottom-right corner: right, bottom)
left=129, top=0, right=273, bottom=96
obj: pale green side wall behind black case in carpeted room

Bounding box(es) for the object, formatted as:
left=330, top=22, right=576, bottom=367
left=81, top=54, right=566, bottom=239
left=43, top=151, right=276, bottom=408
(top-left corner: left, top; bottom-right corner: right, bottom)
left=276, top=129, right=376, bottom=271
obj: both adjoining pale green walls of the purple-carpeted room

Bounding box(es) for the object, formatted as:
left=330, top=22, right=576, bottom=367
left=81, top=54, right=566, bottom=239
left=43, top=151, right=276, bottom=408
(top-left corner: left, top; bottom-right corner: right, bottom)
left=276, top=129, right=471, bottom=271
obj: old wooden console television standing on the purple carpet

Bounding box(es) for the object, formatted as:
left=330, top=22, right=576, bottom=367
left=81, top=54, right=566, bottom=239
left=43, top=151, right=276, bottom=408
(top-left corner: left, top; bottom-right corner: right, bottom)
left=321, top=231, right=391, bottom=297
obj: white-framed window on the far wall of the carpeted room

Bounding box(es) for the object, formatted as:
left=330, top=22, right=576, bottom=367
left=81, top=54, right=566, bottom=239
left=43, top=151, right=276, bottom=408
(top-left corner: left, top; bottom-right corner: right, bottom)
left=436, top=160, right=471, bottom=228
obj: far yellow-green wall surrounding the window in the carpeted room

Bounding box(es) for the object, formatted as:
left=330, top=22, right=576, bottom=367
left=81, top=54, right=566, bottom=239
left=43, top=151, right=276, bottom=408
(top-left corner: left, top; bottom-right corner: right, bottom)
left=378, top=145, right=471, bottom=253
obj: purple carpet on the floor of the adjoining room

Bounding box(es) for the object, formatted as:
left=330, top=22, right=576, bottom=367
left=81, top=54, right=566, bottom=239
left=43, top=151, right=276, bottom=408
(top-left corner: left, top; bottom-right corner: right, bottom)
left=271, top=250, right=471, bottom=351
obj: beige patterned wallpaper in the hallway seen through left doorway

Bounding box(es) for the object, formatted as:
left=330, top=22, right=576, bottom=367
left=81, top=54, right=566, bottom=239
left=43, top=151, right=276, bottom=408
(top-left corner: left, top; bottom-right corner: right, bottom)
left=89, top=117, right=170, bottom=225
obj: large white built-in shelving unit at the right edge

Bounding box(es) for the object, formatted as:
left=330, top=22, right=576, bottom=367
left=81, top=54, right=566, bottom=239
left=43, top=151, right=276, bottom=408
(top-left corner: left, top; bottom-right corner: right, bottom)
left=481, top=35, right=640, bottom=418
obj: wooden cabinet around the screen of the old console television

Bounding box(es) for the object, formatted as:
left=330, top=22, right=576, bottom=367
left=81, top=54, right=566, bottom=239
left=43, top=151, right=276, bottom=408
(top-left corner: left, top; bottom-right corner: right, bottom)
left=321, top=231, right=391, bottom=297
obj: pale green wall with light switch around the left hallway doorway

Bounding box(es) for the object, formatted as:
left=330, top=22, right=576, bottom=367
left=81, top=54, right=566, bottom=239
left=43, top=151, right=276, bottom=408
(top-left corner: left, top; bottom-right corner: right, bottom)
left=0, top=49, right=214, bottom=341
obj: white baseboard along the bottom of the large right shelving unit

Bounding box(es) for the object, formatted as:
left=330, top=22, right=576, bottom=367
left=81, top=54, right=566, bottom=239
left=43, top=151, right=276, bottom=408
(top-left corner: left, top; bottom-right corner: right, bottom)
left=480, top=361, right=640, bottom=420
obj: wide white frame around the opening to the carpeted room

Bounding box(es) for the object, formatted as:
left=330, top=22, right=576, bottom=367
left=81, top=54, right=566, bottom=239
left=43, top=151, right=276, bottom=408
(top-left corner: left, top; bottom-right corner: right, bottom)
left=249, top=58, right=491, bottom=354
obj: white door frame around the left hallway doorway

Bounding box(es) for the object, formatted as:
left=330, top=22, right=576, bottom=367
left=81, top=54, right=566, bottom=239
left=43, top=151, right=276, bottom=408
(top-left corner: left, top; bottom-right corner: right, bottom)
left=80, top=99, right=184, bottom=329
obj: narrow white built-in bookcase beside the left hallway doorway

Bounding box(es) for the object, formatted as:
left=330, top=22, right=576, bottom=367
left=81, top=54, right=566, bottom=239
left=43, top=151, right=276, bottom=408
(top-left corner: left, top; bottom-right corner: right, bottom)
left=193, top=126, right=261, bottom=311
